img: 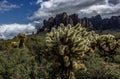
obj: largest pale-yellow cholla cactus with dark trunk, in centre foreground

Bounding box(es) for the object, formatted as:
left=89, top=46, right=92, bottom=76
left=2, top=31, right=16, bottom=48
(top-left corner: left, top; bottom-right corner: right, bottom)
left=46, top=24, right=95, bottom=79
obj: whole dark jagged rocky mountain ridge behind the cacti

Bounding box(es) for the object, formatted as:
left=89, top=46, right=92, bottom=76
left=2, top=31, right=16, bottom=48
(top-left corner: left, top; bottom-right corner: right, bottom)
left=37, top=12, right=120, bottom=33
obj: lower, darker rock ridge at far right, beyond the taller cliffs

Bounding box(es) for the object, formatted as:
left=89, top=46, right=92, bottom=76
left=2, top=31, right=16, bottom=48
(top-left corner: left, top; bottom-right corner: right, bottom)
left=89, top=15, right=120, bottom=30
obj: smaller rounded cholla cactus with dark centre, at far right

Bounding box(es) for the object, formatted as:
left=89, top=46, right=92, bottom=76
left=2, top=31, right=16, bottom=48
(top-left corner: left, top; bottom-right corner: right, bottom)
left=98, top=34, right=118, bottom=55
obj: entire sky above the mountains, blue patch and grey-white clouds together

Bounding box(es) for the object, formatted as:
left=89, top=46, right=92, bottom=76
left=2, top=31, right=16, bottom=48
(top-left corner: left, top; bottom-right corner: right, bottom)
left=0, top=0, right=120, bottom=39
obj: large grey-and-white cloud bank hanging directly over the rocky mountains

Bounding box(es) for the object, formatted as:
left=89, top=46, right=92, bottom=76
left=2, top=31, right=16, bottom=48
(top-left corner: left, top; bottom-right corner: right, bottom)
left=30, top=0, right=120, bottom=19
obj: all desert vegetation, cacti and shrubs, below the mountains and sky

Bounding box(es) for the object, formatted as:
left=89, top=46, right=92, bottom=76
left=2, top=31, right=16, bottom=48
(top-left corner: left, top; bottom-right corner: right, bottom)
left=0, top=24, right=120, bottom=79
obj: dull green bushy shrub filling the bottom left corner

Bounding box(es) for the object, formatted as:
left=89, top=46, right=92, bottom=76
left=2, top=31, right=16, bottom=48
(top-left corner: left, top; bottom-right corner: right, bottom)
left=0, top=48, right=39, bottom=79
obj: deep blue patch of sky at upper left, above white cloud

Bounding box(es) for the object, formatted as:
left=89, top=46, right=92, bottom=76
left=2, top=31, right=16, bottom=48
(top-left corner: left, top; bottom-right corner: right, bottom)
left=0, top=0, right=39, bottom=24
